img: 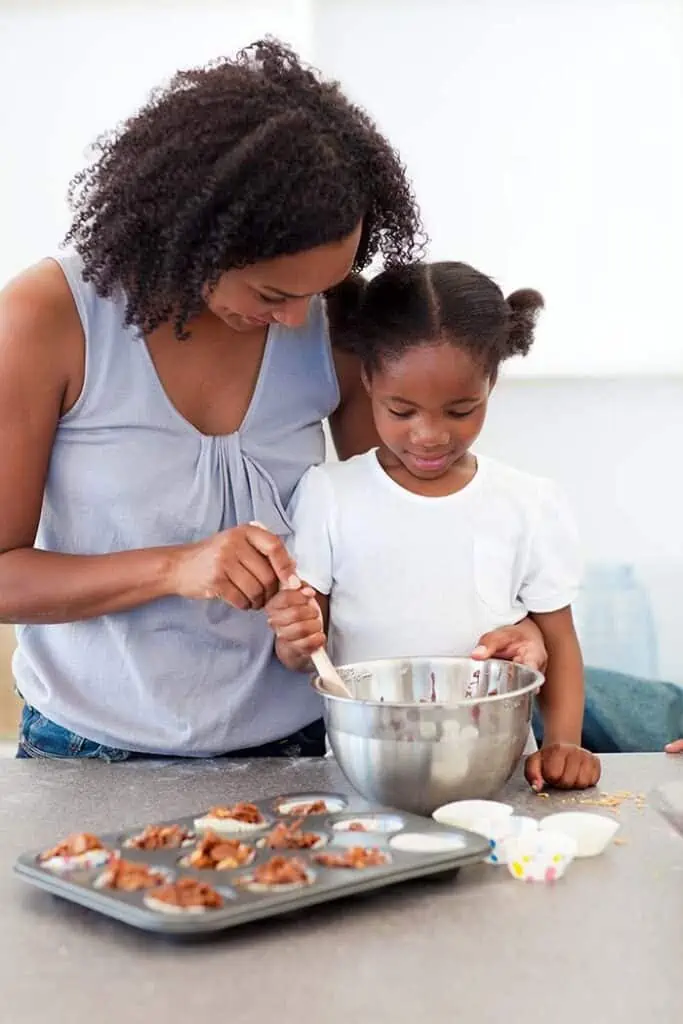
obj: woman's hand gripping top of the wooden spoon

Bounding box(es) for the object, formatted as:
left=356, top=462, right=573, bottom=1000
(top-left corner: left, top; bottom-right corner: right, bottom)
left=172, top=524, right=296, bottom=611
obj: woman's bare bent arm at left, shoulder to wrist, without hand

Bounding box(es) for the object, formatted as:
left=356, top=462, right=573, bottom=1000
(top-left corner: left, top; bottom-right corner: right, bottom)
left=0, top=261, right=174, bottom=623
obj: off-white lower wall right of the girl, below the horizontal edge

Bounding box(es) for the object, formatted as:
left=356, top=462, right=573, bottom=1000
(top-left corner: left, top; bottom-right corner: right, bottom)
left=478, top=379, right=683, bottom=684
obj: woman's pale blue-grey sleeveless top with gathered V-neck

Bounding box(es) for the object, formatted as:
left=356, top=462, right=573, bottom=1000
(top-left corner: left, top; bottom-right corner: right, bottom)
left=14, top=255, right=339, bottom=757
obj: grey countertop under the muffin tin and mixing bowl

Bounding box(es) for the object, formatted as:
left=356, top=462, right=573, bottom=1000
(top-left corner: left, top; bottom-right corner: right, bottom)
left=0, top=755, right=683, bottom=1024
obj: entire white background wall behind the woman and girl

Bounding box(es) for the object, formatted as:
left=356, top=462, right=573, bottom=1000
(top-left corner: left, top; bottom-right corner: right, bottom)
left=0, top=0, right=683, bottom=682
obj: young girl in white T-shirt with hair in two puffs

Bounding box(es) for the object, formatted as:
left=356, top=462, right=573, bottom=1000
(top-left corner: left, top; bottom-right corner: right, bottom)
left=267, top=263, right=600, bottom=788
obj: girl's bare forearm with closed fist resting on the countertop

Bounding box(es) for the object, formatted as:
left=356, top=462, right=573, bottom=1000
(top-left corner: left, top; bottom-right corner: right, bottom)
left=525, top=607, right=600, bottom=792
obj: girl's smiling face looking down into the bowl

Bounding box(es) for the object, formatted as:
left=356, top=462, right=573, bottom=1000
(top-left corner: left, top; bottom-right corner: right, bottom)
left=364, top=342, right=493, bottom=480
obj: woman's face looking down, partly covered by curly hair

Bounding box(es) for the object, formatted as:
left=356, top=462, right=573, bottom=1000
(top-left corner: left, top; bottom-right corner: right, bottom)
left=204, top=222, right=362, bottom=331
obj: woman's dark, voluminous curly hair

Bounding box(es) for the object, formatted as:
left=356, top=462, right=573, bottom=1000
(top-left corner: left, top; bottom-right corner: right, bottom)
left=66, top=39, right=422, bottom=337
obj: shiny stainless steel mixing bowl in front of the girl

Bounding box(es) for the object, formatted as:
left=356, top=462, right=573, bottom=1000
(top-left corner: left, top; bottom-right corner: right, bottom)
left=313, top=657, right=544, bottom=814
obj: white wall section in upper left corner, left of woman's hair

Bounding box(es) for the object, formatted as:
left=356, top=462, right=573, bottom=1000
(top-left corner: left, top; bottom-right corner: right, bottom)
left=0, top=0, right=312, bottom=283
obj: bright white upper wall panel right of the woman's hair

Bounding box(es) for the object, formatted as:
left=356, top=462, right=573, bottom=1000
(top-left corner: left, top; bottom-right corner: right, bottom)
left=315, top=0, right=683, bottom=375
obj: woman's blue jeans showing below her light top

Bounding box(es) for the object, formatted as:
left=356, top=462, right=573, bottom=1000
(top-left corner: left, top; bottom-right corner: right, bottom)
left=16, top=705, right=325, bottom=762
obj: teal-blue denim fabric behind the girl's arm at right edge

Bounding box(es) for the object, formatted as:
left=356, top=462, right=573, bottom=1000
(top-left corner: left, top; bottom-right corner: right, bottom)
left=533, top=669, right=683, bottom=754
